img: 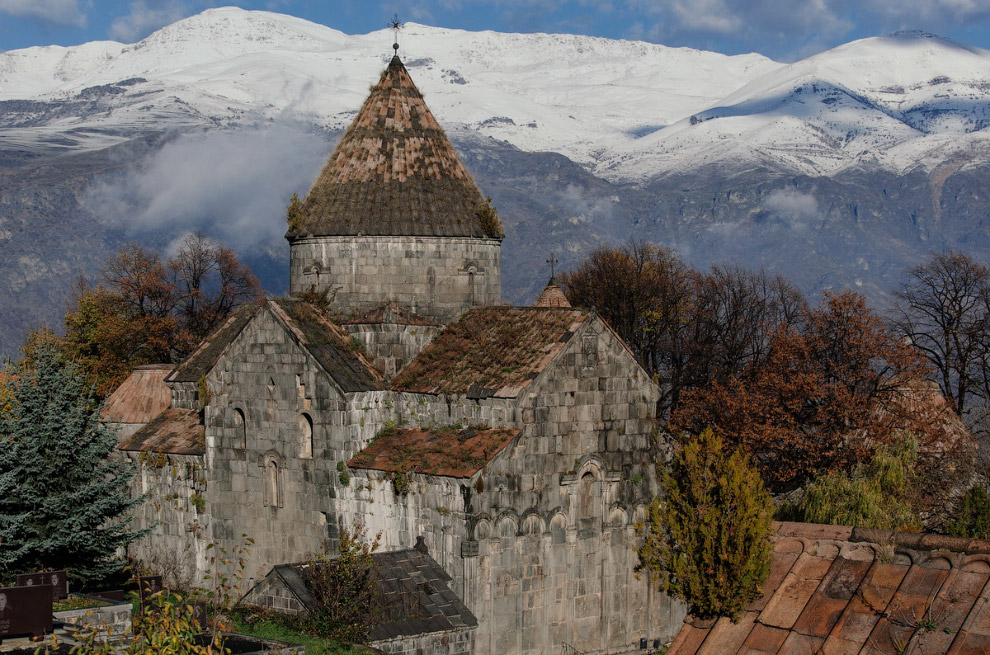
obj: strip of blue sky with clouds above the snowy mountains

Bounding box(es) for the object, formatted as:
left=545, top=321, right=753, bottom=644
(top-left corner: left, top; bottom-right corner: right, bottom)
left=0, top=0, right=990, bottom=60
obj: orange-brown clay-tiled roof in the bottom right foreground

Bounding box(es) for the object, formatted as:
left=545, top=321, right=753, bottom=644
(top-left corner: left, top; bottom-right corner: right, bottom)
left=668, top=523, right=990, bottom=655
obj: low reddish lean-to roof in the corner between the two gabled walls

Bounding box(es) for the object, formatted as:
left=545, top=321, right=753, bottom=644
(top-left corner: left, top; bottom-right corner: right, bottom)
left=347, top=426, right=521, bottom=478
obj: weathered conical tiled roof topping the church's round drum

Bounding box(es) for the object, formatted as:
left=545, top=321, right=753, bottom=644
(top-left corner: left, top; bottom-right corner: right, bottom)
left=286, top=56, right=501, bottom=239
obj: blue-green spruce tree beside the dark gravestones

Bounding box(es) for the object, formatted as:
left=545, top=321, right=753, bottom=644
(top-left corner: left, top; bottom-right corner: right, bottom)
left=0, top=345, right=141, bottom=584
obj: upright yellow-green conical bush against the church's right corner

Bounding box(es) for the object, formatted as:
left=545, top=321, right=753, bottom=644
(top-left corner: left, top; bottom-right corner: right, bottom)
left=639, top=430, right=773, bottom=621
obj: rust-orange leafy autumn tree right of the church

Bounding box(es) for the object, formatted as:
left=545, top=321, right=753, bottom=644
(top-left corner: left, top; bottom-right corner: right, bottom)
left=670, top=293, right=926, bottom=491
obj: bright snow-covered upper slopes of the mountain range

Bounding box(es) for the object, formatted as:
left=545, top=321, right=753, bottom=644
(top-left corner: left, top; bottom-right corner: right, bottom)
left=0, top=8, right=990, bottom=182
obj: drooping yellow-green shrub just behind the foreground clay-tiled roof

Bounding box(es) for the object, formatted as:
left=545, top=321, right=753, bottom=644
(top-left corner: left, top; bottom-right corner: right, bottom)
left=797, top=436, right=921, bottom=530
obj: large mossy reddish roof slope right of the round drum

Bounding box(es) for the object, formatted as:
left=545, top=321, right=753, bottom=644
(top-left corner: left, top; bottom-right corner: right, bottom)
left=392, top=307, right=589, bottom=398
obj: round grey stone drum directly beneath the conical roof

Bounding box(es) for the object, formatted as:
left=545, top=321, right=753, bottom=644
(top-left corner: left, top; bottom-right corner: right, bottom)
left=289, top=237, right=502, bottom=323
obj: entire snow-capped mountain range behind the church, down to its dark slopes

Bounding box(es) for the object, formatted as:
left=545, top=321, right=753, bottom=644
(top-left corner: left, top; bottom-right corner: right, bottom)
left=0, top=9, right=990, bottom=354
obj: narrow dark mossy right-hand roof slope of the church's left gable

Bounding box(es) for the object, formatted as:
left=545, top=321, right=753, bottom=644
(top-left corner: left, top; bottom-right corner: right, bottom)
left=268, top=298, right=382, bottom=393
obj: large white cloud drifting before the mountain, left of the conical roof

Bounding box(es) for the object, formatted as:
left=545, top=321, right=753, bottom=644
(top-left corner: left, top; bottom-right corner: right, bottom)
left=82, top=125, right=329, bottom=252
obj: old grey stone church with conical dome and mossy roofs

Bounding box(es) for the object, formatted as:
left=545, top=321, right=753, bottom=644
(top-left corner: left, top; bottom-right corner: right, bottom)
left=107, top=47, right=685, bottom=655
